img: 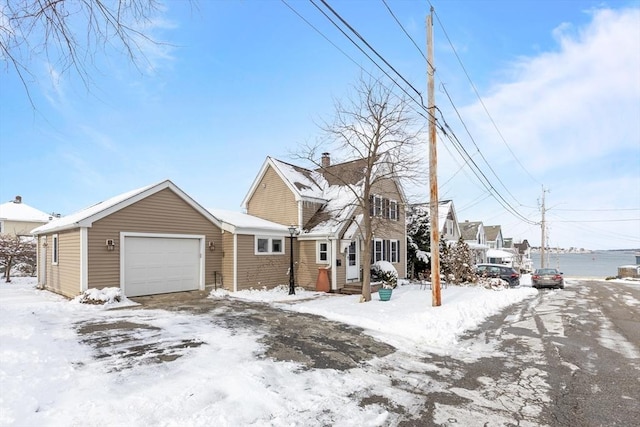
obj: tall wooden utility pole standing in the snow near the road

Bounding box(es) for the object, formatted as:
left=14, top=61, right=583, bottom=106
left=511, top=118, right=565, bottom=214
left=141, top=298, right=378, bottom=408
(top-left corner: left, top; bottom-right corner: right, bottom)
left=427, top=6, right=442, bottom=307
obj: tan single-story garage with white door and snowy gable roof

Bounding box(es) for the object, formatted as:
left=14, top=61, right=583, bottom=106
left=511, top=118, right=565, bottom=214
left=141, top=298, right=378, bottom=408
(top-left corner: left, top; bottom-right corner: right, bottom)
left=32, top=180, right=224, bottom=297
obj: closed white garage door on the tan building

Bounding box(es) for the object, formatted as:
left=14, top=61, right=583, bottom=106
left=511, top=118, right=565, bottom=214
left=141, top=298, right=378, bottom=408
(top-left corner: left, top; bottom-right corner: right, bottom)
left=124, top=236, right=200, bottom=297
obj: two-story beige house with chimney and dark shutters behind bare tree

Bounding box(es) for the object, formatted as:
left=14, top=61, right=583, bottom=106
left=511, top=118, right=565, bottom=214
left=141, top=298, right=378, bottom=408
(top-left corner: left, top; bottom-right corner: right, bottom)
left=242, top=153, right=406, bottom=291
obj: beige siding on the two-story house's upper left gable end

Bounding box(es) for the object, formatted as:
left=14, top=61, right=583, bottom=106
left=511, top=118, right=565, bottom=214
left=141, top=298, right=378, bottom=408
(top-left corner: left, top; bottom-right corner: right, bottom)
left=247, top=166, right=298, bottom=225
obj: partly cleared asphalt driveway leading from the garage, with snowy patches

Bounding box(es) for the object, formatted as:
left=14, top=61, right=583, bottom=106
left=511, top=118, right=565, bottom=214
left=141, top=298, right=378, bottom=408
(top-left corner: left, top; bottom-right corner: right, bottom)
left=76, top=291, right=395, bottom=370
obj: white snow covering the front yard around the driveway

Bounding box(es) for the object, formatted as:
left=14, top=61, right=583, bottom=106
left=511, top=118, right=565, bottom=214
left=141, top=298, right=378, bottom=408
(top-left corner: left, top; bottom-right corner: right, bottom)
left=0, top=275, right=608, bottom=426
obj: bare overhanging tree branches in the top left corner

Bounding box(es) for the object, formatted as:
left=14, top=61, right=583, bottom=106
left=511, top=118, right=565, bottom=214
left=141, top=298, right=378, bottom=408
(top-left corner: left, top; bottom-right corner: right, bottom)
left=0, top=0, right=169, bottom=104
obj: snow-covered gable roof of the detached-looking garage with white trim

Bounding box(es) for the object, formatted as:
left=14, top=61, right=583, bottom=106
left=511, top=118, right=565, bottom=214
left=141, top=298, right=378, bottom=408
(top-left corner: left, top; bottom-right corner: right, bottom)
left=31, top=179, right=220, bottom=234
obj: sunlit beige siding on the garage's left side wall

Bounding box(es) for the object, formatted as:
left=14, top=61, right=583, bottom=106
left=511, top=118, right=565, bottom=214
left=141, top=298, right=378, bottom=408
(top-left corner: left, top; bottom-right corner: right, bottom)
left=39, top=229, right=81, bottom=298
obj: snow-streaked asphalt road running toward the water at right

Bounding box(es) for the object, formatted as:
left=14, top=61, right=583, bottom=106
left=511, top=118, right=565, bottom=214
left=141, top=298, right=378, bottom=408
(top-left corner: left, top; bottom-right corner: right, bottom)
left=399, top=281, right=640, bottom=426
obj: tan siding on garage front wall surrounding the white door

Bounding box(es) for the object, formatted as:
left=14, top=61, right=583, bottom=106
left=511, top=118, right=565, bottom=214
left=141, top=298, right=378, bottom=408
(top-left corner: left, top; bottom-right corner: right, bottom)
left=88, top=189, right=223, bottom=288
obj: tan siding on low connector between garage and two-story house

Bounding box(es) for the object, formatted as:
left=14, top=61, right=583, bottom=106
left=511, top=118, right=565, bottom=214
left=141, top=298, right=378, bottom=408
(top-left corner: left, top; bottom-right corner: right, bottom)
left=238, top=234, right=297, bottom=290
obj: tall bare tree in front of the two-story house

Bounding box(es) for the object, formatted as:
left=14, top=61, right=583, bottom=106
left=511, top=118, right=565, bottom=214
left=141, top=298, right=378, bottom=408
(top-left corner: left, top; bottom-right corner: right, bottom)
left=298, top=77, right=425, bottom=301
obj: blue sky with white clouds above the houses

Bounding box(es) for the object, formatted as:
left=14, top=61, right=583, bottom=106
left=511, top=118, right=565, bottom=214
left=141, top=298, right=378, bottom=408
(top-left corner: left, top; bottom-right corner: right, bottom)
left=0, top=0, right=640, bottom=249
